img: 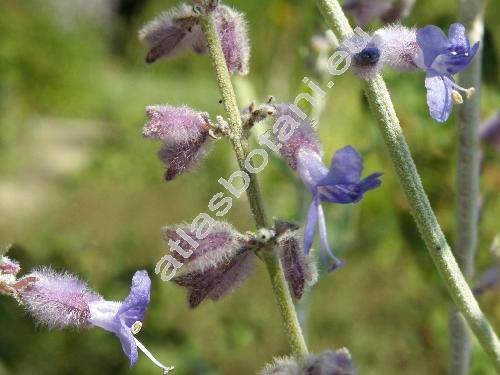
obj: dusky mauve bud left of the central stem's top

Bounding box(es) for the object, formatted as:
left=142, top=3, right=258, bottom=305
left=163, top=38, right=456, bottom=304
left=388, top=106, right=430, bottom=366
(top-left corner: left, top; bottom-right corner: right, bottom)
left=139, top=4, right=206, bottom=63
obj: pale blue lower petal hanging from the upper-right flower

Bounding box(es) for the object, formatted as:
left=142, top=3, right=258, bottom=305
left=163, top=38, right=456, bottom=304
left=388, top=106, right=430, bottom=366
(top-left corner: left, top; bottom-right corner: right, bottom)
left=425, top=70, right=453, bottom=122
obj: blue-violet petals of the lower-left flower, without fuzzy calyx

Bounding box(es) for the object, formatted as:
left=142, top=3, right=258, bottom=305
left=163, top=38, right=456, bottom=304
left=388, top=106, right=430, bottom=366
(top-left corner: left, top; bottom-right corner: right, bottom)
left=89, top=271, right=151, bottom=366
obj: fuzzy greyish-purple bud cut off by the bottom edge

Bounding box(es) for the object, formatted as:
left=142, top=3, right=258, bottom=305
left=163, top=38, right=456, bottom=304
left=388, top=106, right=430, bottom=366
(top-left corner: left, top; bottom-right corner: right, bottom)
left=260, top=348, right=358, bottom=375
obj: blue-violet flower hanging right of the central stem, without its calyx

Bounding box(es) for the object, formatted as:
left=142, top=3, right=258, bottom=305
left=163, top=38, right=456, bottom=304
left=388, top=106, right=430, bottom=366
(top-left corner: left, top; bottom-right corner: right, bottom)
left=297, top=146, right=382, bottom=271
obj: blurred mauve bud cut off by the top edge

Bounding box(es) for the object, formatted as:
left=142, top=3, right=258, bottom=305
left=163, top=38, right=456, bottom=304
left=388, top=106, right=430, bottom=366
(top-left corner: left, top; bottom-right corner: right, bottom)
left=343, top=0, right=415, bottom=28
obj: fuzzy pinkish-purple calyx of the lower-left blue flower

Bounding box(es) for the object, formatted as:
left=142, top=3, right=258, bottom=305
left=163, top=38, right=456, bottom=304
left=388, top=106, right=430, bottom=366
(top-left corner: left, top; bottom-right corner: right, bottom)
left=16, top=268, right=103, bottom=328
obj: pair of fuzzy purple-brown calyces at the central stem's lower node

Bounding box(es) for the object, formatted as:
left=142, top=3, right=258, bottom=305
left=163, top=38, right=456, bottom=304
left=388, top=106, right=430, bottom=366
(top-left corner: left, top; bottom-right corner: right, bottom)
left=164, top=221, right=317, bottom=308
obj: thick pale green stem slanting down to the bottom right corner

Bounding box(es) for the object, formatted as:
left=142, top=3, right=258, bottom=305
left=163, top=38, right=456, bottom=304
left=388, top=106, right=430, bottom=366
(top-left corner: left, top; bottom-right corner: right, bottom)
left=317, top=0, right=500, bottom=372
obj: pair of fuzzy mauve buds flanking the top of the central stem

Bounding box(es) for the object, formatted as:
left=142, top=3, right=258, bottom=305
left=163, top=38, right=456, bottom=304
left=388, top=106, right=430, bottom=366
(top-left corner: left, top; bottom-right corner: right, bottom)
left=139, top=4, right=250, bottom=75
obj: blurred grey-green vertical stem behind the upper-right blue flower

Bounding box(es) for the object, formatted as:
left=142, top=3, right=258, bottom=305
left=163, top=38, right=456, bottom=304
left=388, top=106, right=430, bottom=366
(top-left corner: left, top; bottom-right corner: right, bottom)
left=449, top=0, right=484, bottom=375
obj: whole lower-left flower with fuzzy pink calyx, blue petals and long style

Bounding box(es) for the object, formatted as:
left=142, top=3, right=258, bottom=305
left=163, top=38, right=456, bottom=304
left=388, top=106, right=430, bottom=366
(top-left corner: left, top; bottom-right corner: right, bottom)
left=12, top=268, right=172, bottom=373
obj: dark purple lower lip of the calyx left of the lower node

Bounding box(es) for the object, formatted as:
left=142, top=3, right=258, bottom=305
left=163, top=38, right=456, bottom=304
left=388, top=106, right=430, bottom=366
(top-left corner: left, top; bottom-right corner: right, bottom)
left=172, top=251, right=256, bottom=308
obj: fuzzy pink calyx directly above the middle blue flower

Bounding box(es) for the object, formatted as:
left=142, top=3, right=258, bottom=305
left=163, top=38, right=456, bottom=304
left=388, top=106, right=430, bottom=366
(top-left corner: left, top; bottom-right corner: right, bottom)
left=273, top=104, right=323, bottom=170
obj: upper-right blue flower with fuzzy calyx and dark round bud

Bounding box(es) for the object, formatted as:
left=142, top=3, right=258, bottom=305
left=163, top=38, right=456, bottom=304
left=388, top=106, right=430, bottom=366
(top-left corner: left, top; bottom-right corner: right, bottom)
left=341, top=23, right=479, bottom=122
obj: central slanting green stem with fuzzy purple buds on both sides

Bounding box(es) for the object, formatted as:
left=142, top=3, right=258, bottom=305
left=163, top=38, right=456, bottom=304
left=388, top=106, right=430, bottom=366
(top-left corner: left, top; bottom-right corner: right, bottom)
left=201, top=13, right=308, bottom=358
